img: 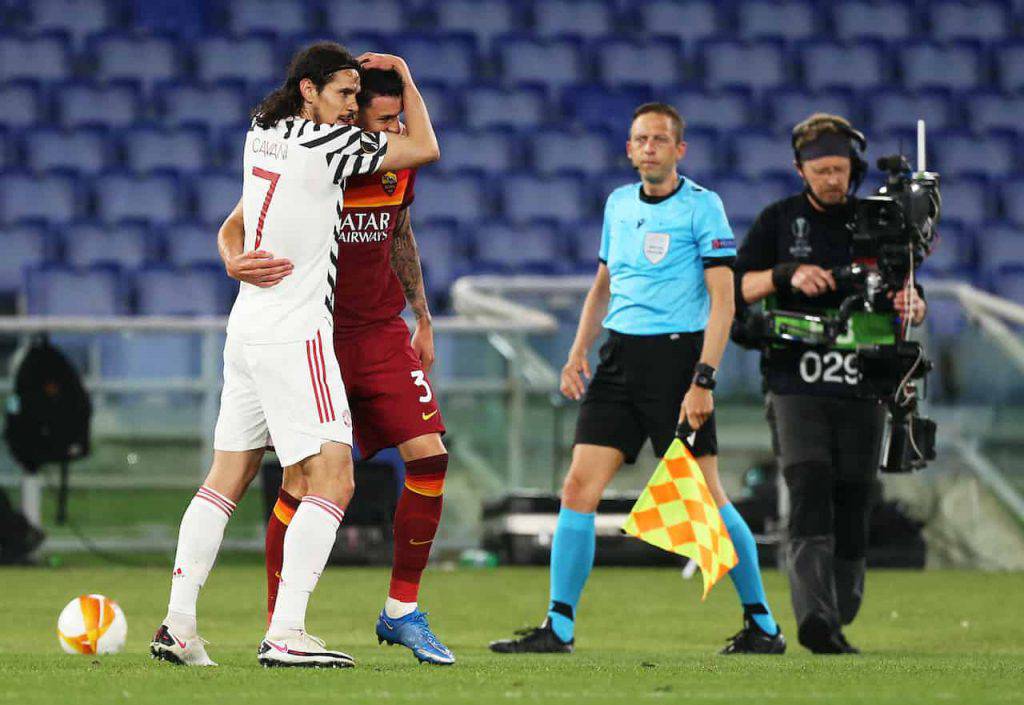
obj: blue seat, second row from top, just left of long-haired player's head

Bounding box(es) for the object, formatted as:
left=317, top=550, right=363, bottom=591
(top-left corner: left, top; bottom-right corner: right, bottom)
left=193, top=36, right=284, bottom=84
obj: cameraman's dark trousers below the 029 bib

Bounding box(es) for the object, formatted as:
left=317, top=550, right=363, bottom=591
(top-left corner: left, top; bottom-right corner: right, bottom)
left=768, top=393, right=886, bottom=642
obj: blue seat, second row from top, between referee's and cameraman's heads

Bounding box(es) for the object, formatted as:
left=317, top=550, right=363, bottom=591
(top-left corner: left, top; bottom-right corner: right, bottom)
left=701, top=40, right=790, bottom=90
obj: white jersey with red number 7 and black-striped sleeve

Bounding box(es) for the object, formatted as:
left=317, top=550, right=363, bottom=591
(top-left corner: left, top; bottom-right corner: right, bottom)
left=227, top=118, right=387, bottom=343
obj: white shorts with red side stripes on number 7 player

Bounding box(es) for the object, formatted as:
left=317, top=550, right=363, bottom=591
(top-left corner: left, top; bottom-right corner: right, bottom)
left=213, top=326, right=352, bottom=466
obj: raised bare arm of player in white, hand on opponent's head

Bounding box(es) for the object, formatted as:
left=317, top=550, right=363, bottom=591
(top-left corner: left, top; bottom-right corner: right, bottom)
left=358, top=53, right=441, bottom=169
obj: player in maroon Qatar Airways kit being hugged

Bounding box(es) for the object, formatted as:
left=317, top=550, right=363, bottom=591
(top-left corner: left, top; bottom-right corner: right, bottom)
left=218, top=64, right=455, bottom=664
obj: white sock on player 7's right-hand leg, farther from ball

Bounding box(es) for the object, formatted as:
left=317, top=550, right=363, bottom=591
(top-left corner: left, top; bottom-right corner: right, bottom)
left=266, top=495, right=345, bottom=637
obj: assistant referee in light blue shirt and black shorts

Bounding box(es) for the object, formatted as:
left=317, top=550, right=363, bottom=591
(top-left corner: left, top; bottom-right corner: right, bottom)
left=490, top=102, right=785, bottom=654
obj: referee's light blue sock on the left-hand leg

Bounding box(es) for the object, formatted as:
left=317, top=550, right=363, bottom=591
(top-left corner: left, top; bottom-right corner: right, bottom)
left=548, top=506, right=594, bottom=641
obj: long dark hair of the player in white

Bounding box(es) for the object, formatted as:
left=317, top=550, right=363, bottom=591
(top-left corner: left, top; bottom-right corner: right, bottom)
left=252, top=42, right=359, bottom=129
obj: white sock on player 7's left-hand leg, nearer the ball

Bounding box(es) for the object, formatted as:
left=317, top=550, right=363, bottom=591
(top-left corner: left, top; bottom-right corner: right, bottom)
left=165, top=485, right=234, bottom=634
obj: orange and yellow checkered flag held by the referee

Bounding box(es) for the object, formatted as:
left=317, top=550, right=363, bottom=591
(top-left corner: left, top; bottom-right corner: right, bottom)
left=623, top=439, right=739, bottom=599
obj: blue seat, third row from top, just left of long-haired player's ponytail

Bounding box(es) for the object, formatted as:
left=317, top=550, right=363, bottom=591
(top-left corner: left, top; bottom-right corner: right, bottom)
left=156, top=81, right=250, bottom=128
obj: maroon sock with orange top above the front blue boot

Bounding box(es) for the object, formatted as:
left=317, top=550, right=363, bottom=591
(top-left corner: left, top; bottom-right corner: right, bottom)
left=388, top=453, right=447, bottom=603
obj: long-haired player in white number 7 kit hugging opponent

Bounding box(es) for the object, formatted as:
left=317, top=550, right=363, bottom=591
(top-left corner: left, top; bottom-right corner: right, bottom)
left=151, top=42, right=439, bottom=667
